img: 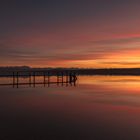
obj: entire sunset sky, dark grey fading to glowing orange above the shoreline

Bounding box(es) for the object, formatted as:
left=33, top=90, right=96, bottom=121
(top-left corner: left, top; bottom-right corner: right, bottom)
left=0, top=0, right=140, bottom=68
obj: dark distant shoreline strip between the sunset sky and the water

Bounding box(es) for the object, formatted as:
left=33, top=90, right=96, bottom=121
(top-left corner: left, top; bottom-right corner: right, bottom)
left=0, top=66, right=140, bottom=77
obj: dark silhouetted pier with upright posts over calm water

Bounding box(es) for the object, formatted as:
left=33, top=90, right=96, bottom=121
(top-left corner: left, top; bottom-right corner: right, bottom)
left=0, top=71, right=77, bottom=88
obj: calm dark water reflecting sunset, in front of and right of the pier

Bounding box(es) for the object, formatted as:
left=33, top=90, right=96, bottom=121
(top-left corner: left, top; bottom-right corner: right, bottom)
left=0, top=76, right=140, bottom=140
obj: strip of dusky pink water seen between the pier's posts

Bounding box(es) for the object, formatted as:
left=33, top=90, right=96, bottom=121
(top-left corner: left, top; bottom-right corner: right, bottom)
left=0, top=74, right=77, bottom=88
